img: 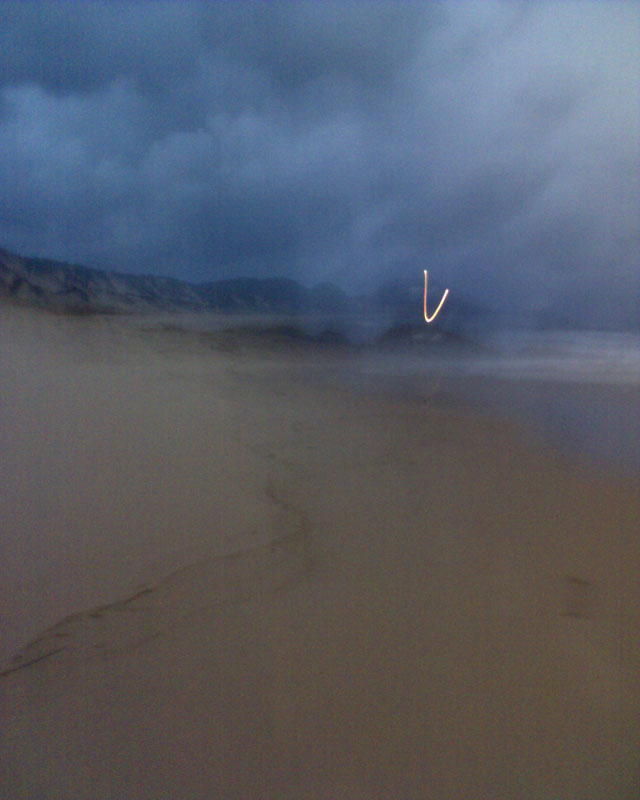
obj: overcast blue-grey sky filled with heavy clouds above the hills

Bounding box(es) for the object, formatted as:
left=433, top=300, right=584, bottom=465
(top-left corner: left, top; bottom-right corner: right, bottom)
left=0, top=0, right=640, bottom=324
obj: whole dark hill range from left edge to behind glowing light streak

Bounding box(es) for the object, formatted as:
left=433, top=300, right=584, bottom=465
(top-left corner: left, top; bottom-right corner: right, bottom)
left=0, top=249, right=488, bottom=348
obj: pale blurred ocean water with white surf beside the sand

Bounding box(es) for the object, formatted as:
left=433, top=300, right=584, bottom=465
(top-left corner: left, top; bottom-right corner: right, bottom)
left=350, top=331, right=640, bottom=477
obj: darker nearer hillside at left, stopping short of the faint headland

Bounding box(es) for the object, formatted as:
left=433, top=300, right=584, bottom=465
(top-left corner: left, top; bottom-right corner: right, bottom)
left=0, top=249, right=349, bottom=314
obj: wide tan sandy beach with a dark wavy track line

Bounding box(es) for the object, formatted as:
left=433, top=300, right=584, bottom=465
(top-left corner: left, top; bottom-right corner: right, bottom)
left=0, top=307, right=640, bottom=800
